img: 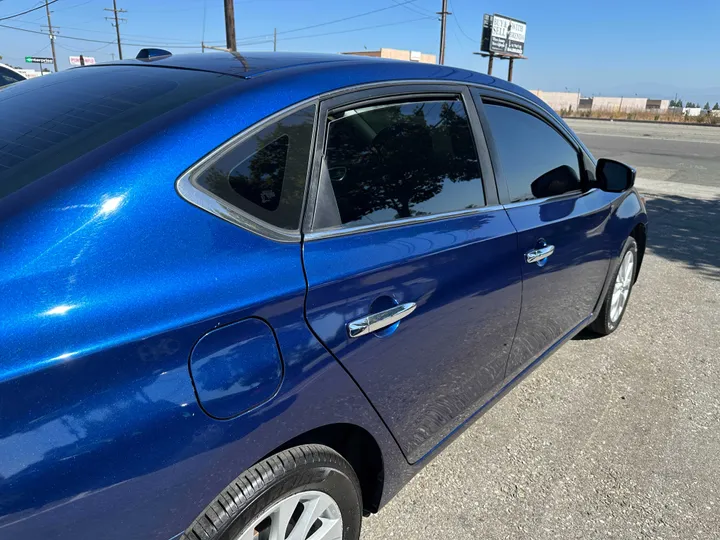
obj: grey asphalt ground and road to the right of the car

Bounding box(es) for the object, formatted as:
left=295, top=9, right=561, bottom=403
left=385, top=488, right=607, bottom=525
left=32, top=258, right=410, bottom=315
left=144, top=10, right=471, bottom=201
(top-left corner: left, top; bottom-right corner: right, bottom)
left=362, top=122, right=720, bottom=540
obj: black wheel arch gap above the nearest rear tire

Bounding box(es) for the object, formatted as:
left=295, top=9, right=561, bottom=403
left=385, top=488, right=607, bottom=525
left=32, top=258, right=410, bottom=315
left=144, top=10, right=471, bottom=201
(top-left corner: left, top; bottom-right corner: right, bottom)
left=259, top=423, right=385, bottom=514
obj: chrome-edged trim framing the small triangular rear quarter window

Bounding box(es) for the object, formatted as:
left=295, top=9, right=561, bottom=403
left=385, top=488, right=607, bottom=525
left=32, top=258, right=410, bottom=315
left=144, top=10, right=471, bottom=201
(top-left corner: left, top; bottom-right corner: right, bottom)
left=175, top=97, right=320, bottom=243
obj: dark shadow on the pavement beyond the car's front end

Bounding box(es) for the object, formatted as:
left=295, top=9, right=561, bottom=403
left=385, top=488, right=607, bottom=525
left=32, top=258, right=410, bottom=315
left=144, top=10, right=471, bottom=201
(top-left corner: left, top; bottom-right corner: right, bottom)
left=647, top=195, right=720, bottom=280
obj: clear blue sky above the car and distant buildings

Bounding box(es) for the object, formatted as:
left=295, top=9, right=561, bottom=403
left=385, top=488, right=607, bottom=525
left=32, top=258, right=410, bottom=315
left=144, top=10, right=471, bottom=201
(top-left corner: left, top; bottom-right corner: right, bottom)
left=0, top=0, right=720, bottom=102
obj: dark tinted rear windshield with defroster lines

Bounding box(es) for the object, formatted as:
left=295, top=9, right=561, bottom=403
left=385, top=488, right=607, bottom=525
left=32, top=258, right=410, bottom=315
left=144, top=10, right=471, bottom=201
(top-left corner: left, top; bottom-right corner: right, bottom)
left=0, top=66, right=238, bottom=197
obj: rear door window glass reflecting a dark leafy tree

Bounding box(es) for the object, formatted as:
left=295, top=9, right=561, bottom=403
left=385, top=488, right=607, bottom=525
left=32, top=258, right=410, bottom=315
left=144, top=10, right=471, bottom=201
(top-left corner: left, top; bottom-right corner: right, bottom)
left=326, top=100, right=485, bottom=225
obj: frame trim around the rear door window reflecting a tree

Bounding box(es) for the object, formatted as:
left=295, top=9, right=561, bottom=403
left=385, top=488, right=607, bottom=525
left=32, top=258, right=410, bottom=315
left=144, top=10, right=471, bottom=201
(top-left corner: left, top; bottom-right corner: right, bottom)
left=303, top=81, right=502, bottom=241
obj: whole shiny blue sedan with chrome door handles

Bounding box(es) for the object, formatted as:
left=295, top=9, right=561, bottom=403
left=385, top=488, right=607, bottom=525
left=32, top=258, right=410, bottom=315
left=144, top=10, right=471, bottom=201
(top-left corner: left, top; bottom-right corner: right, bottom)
left=0, top=51, right=647, bottom=540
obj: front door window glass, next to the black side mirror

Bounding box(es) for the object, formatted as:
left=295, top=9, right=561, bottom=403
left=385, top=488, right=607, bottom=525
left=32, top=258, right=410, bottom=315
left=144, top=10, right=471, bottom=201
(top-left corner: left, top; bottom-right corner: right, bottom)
left=485, top=104, right=580, bottom=202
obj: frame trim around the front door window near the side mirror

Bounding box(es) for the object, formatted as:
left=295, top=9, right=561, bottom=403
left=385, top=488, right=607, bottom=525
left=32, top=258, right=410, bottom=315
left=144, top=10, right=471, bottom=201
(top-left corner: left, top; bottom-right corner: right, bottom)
left=473, top=86, right=596, bottom=208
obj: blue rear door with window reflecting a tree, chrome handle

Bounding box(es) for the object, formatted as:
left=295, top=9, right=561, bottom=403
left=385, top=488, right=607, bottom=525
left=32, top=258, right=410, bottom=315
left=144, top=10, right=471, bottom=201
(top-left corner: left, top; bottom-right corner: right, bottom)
left=303, top=85, right=521, bottom=462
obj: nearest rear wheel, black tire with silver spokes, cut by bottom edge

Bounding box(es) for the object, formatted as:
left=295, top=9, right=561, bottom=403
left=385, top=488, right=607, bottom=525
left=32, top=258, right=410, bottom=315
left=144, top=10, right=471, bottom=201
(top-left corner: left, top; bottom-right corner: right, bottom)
left=180, top=444, right=362, bottom=540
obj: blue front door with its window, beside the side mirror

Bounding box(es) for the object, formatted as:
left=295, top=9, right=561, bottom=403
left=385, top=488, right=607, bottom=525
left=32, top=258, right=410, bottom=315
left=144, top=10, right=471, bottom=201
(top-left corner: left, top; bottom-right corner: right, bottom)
left=473, top=90, right=617, bottom=379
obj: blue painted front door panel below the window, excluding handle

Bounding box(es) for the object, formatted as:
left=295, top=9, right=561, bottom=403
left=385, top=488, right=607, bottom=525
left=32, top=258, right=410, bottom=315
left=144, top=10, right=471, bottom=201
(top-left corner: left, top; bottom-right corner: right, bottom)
left=506, top=190, right=618, bottom=380
